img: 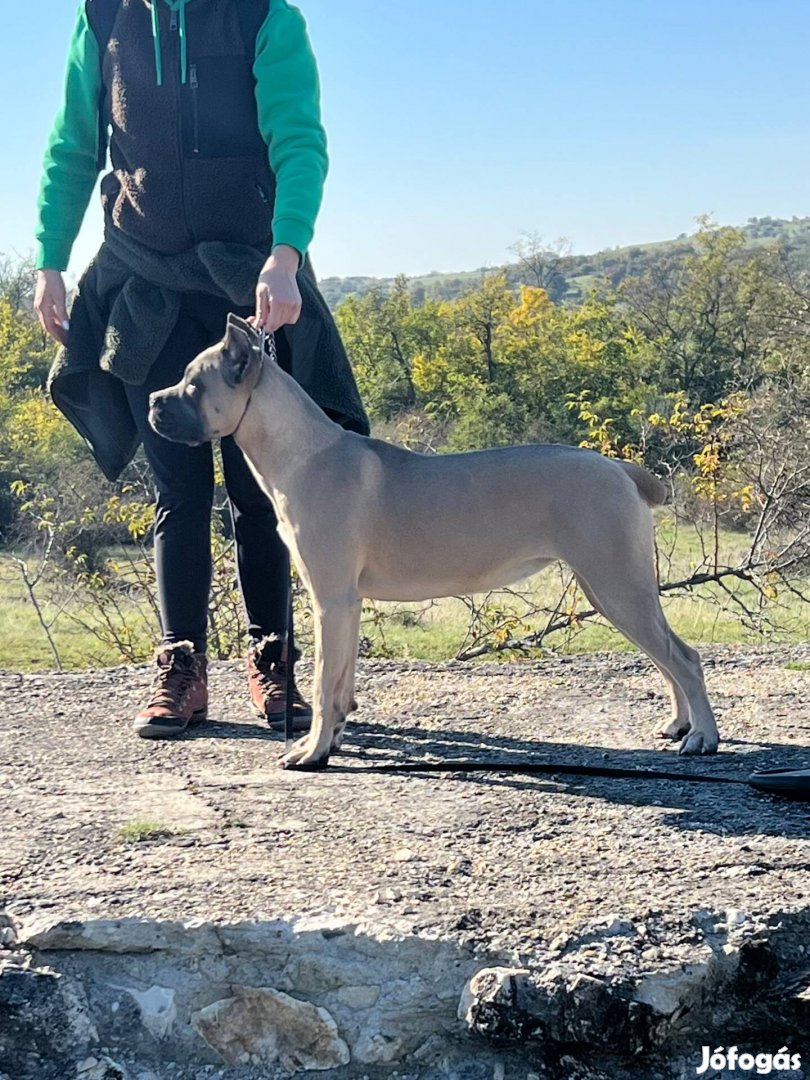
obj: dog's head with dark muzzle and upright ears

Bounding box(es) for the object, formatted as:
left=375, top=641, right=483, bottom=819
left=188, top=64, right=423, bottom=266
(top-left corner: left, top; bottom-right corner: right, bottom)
left=149, top=314, right=262, bottom=446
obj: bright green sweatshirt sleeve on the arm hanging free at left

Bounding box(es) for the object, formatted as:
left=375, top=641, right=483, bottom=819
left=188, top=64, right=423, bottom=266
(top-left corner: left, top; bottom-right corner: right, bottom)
left=36, top=3, right=102, bottom=270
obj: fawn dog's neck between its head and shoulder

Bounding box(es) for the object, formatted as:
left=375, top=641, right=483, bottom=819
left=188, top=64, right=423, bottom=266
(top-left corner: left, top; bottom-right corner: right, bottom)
left=233, top=352, right=347, bottom=494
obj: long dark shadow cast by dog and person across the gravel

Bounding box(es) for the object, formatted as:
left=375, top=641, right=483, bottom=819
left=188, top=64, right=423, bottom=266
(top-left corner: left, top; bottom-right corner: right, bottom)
left=186, top=720, right=810, bottom=837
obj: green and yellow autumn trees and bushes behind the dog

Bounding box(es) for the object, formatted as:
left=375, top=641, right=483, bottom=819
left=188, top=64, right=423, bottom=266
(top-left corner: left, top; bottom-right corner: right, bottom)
left=0, top=221, right=810, bottom=658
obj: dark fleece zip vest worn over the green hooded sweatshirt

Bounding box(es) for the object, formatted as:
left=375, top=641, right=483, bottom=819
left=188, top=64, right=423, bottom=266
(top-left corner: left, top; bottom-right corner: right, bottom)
left=86, top=0, right=275, bottom=254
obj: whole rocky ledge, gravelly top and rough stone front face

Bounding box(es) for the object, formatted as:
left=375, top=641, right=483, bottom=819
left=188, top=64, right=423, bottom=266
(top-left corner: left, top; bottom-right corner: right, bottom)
left=0, top=646, right=810, bottom=1080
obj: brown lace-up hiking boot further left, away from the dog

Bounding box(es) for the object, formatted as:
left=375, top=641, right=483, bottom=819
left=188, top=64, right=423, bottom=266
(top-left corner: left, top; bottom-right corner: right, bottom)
left=133, top=642, right=208, bottom=739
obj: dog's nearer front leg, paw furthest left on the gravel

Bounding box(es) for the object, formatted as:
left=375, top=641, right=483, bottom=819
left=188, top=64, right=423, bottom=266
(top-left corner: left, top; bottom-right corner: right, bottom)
left=281, top=603, right=357, bottom=769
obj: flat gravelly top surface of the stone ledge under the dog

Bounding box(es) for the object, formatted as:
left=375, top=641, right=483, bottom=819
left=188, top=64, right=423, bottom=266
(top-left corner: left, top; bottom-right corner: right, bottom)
left=0, top=646, right=810, bottom=1075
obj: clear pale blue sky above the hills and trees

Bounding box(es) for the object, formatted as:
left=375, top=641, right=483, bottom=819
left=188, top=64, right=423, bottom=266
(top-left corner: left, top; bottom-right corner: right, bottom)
left=0, top=0, right=810, bottom=276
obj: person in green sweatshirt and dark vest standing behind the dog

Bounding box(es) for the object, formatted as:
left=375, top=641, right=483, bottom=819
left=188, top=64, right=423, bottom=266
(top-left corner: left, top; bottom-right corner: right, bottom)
left=35, top=0, right=368, bottom=739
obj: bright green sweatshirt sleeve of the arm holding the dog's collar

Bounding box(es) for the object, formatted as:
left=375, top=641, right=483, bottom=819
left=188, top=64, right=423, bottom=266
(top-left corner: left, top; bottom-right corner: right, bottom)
left=253, top=0, right=328, bottom=259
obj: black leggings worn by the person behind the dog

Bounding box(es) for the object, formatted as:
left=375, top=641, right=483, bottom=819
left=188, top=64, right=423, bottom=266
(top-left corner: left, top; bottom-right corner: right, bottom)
left=126, top=294, right=289, bottom=652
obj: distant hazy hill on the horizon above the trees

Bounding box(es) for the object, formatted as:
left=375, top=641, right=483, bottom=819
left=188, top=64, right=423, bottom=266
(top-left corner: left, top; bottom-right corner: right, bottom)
left=319, top=217, right=810, bottom=310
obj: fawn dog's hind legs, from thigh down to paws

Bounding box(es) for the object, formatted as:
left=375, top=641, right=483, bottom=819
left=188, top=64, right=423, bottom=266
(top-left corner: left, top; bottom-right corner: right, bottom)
left=573, top=538, right=718, bottom=754
